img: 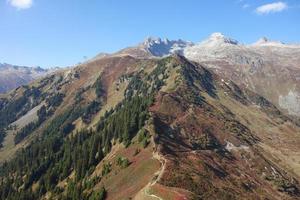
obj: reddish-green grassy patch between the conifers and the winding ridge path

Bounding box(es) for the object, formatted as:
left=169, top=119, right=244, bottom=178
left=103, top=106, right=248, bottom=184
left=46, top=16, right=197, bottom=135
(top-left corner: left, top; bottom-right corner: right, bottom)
left=96, top=142, right=160, bottom=199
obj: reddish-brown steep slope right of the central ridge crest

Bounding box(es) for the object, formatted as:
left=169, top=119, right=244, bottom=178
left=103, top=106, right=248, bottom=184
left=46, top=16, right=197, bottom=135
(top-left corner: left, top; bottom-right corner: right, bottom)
left=151, top=55, right=300, bottom=199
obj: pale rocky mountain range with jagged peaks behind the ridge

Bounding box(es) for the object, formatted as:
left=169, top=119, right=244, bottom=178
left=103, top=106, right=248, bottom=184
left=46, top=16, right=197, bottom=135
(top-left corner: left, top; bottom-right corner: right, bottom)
left=96, top=33, right=300, bottom=117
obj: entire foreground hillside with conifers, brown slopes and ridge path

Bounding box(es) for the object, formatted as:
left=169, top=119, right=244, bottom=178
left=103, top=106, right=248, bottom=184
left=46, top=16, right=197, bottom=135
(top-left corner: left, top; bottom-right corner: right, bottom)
left=0, top=54, right=300, bottom=199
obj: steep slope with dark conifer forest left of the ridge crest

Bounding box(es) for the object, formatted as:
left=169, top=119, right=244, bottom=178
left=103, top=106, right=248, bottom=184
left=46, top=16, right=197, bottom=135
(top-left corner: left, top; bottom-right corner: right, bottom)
left=0, top=56, right=169, bottom=199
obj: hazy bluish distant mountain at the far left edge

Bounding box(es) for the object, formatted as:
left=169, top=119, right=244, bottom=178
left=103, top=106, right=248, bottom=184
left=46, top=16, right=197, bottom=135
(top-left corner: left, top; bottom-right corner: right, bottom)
left=0, top=63, right=51, bottom=93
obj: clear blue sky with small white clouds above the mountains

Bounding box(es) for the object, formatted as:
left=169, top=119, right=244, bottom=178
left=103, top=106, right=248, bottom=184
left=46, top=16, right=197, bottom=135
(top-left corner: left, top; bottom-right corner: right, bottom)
left=0, top=0, right=300, bottom=68
